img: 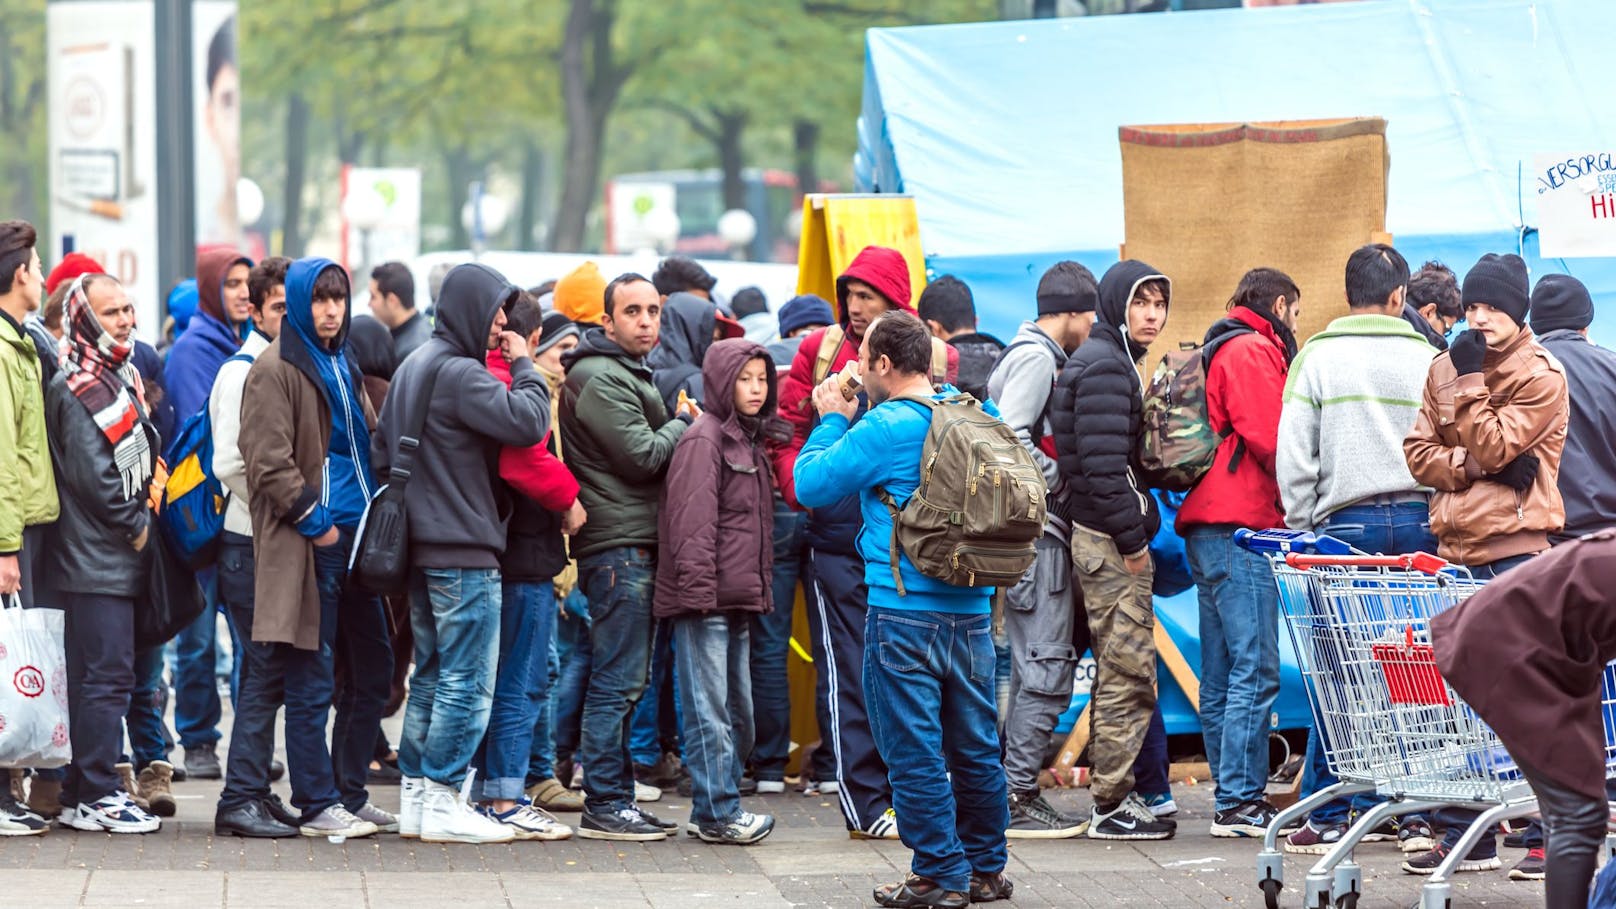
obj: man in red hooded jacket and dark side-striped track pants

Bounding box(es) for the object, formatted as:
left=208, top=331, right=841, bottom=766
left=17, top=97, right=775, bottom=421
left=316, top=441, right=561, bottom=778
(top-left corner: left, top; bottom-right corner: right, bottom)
left=774, top=246, right=960, bottom=839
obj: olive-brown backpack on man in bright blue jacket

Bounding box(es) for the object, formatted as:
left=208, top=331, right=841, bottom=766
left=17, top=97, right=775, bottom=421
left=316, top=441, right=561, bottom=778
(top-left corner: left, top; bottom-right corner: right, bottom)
left=879, top=393, right=1044, bottom=597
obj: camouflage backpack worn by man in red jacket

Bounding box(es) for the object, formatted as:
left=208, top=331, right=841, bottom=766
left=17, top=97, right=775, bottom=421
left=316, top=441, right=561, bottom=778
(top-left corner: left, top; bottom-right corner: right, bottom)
left=1139, top=325, right=1254, bottom=492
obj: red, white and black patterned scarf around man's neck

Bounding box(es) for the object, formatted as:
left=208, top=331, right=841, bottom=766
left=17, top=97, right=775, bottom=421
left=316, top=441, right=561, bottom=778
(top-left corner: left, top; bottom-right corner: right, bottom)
left=61, top=277, right=154, bottom=498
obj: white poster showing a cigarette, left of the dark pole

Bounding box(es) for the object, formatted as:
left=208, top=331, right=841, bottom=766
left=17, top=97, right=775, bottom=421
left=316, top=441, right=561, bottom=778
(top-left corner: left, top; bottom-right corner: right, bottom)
left=48, top=0, right=160, bottom=333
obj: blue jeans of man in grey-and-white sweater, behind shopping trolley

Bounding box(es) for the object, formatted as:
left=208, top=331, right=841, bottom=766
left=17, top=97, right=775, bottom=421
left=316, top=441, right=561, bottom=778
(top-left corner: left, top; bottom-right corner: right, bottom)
left=1302, top=501, right=1437, bottom=828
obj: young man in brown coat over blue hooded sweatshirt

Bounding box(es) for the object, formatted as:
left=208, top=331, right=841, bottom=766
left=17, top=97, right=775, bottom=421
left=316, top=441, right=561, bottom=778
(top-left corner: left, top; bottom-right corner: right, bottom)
left=238, top=259, right=398, bottom=836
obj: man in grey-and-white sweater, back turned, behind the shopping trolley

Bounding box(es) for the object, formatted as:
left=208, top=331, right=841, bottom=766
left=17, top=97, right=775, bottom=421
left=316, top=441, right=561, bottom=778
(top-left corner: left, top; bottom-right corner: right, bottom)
left=1269, top=243, right=1437, bottom=856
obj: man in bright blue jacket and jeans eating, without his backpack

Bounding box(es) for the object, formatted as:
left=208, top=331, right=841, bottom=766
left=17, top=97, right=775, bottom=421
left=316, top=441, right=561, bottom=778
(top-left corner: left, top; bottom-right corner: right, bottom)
left=795, top=311, right=1012, bottom=909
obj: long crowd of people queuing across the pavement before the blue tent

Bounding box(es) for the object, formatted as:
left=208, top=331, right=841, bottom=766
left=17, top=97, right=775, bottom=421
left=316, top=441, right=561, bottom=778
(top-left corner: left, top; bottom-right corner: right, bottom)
left=0, top=213, right=1616, bottom=906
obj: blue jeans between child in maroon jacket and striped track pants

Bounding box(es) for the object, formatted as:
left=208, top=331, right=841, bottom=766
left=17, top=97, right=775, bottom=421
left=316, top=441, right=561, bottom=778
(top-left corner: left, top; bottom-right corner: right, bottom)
left=750, top=500, right=808, bottom=783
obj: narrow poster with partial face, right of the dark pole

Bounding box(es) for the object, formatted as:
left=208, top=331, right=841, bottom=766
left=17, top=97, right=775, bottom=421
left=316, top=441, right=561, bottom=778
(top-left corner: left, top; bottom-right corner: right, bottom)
left=191, top=0, right=242, bottom=247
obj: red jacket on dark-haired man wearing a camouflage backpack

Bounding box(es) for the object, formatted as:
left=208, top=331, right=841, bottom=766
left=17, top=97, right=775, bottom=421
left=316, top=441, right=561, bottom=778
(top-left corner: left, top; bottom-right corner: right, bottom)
left=1176, top=306, right=1290, bottom=534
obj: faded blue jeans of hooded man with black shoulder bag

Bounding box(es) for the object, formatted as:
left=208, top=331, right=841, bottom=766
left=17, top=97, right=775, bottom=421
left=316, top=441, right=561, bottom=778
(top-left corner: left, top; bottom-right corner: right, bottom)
left=399, top=568, right=503, bottom=788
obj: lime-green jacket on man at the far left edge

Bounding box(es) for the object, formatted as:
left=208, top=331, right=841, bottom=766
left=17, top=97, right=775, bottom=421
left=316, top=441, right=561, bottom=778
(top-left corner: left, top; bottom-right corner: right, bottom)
left=0, top=315, right=61, bottom=553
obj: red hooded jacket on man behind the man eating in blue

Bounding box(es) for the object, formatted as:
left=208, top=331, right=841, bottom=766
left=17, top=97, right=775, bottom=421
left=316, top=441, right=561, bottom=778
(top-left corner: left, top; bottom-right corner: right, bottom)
left=769, top=246, right=960, bottom=508
